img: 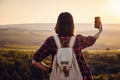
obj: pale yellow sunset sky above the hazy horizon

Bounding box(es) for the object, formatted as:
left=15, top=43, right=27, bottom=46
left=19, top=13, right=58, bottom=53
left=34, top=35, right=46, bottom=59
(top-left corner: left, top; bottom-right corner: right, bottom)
left=0, top=0, right=120, bottom=25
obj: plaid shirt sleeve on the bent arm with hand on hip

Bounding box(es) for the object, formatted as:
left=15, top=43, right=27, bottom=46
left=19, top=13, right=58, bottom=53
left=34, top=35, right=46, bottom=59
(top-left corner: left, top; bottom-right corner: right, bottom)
left=33, top=37, right=52, bottom=62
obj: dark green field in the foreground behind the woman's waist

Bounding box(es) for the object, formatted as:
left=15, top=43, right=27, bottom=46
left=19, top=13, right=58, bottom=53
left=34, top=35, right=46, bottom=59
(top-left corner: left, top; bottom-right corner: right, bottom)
left=0, top=49, right=120, bottom=80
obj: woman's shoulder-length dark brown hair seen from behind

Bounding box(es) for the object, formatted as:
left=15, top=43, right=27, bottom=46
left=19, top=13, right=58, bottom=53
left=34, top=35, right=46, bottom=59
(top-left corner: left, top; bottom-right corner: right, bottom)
left=54, top=12, right=74, bottom=36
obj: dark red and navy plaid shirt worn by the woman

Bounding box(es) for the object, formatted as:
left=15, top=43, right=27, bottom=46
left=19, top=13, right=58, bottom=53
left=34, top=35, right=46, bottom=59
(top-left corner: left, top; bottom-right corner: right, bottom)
left=34, top=35, right=96, bottom=80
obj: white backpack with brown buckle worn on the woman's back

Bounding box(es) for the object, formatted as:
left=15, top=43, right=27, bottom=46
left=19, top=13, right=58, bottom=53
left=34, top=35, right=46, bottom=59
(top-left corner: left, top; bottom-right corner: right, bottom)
left=50, top=35, right=83, bottom=80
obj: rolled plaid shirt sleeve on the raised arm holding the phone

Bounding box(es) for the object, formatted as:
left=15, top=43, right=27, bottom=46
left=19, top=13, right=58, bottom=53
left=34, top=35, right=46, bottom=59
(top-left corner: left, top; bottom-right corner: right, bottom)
left=78, top=36, right=96, bottom=49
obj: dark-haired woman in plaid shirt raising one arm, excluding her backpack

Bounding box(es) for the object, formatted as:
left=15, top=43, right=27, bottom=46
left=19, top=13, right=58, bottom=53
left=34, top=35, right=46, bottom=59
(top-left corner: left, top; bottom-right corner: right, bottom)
left=32, top=12, right=102, bottom=80
